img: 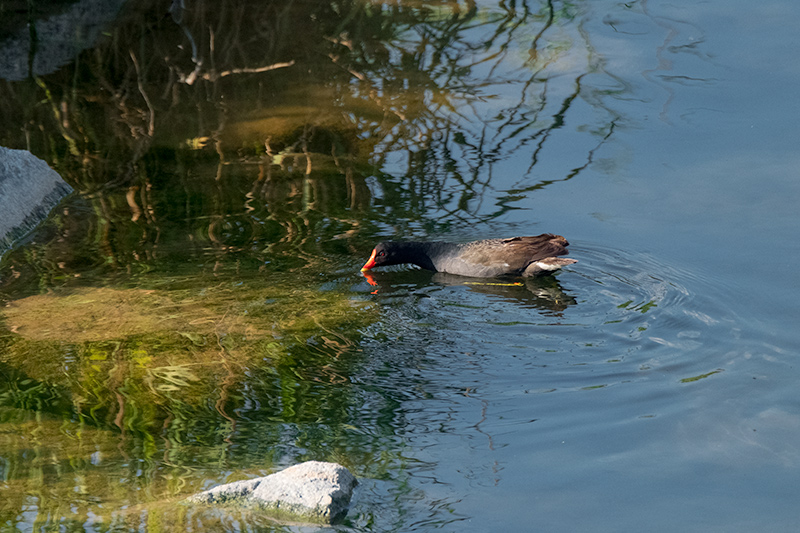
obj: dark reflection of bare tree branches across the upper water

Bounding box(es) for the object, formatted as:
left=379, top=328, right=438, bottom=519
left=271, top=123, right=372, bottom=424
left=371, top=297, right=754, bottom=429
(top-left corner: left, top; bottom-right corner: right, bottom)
left=0, top=1, right=618, bottom=245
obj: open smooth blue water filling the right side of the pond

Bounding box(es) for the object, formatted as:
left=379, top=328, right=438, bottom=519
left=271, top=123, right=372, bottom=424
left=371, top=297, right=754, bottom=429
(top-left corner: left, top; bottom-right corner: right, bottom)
left=356, top=2, right=800, bottom=531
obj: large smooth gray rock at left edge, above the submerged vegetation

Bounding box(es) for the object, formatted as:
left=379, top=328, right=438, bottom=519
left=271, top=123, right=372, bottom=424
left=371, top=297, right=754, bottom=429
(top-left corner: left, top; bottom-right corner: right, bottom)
left=0, top=146, right=72, bottom=255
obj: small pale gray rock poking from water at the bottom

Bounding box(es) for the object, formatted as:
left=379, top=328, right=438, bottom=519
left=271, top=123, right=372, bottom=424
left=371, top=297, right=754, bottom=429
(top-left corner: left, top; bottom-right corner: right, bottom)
left=188, top=461, right=358, bottom=523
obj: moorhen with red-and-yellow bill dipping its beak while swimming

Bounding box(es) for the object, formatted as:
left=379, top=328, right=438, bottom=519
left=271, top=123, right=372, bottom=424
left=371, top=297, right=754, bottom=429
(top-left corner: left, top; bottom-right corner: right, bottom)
left=361, top=233, right=577, bottom=278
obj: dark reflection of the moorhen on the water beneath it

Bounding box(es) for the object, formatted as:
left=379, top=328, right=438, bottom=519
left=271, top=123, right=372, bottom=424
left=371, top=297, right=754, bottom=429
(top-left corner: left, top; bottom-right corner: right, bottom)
left=362, top=270, right=578, bottom=312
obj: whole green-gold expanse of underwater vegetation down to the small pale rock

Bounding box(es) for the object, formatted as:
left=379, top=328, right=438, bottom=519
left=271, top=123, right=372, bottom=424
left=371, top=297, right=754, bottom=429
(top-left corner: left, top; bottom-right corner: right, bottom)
left=0, top=275, right=374, bottom=521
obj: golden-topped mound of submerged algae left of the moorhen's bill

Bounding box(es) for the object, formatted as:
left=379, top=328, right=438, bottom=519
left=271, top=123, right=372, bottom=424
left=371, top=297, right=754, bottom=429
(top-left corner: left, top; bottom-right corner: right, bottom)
left=2, top=280, right=370, bottom=431
